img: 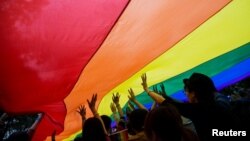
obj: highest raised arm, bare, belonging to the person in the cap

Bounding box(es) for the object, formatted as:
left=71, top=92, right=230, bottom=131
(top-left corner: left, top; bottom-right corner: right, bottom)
left=141, top=74, right=165, bottom=104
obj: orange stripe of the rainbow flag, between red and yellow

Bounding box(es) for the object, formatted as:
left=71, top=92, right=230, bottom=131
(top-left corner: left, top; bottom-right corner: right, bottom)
left=60, top=0, right=230, bottom=140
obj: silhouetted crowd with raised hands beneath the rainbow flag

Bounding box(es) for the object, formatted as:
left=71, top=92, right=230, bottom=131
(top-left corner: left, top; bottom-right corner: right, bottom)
left=1, top=73, right=250, bottom=141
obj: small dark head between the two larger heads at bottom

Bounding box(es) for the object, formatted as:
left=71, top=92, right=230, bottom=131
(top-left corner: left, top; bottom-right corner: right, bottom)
left=128, top=109, right=148, bottom=132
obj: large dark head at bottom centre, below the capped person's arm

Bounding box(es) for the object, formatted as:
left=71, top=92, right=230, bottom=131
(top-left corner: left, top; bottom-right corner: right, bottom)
left=144, top=104, right=183, bottom=141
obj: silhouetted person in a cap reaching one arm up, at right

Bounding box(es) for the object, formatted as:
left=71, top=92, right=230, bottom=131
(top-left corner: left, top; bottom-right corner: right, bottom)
left=142, top=73, right=238, bottom=141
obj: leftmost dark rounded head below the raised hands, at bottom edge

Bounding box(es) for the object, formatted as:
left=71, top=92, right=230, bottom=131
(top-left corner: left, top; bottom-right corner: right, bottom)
left=82, top=117, right=106, bottom=141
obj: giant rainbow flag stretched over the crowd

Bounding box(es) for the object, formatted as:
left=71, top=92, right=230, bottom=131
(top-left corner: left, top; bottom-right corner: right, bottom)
left=0, top=0, right=250, bottom=141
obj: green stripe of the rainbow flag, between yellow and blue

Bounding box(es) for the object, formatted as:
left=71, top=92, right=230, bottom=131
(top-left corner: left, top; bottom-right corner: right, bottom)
left=133, top=43, right=250, bottom=107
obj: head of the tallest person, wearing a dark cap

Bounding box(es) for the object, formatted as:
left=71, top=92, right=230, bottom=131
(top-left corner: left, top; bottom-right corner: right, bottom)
left=183, top=73, right=217, bottom=103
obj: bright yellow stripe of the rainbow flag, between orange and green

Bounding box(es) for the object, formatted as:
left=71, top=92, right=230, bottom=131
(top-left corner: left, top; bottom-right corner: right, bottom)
left=98, top=0, right=250, bottom=115
